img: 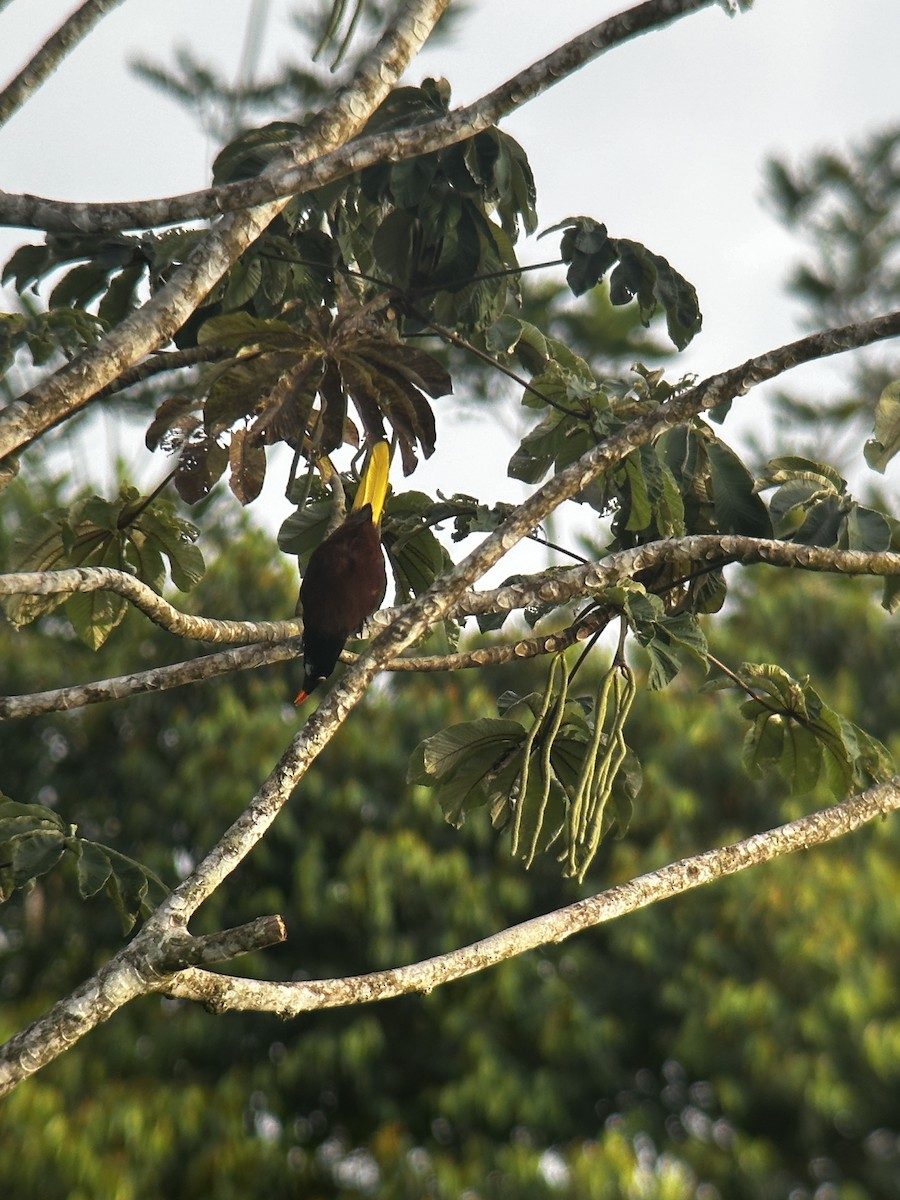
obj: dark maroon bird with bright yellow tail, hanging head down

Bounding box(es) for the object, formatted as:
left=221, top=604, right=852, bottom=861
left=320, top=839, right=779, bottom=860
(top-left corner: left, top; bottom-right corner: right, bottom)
left=294, top=442, right=390, bottom=704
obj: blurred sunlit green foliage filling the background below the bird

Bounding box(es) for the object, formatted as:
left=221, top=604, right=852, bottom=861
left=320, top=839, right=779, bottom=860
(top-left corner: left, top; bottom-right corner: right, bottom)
left=0, top=489, right=900, bottom=1200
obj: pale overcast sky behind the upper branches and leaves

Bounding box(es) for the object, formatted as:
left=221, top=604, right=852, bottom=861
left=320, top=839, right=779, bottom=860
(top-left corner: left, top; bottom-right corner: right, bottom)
left=0, top=0, right=900, bottom=552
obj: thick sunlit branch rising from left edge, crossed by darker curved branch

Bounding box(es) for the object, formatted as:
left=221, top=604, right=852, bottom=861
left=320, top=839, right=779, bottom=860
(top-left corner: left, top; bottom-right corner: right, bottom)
left=0, top=0, right=449, bottom=461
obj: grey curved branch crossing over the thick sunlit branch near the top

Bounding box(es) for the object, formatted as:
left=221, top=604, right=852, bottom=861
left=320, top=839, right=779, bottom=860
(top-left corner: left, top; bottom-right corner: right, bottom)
left=0, top=0, right=716, bottom=233
